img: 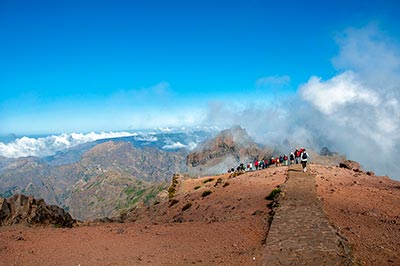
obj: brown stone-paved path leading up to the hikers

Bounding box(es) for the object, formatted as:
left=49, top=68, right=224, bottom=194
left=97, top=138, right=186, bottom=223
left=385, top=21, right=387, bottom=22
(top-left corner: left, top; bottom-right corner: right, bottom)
left=263, top=165, right=351, bottom=265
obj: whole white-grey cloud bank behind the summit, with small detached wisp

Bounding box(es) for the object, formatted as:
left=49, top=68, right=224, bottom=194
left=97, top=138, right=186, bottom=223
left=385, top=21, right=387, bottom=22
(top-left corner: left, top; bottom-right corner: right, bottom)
left=209, top=25, right=400, bottom=179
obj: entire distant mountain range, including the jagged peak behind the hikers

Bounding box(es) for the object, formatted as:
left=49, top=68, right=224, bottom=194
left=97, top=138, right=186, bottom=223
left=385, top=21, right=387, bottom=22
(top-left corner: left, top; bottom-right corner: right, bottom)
left=0, top=126, right=341, bottom=220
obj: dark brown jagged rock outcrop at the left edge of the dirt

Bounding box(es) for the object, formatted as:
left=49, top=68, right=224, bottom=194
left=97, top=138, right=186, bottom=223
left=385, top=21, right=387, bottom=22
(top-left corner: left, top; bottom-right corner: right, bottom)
left=0, top=194, right=76, bottom=227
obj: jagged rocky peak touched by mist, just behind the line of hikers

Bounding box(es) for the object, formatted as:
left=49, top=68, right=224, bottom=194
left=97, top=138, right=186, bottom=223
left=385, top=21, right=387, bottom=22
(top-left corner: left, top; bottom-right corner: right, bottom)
left=186, top=126, right=273, bottom=175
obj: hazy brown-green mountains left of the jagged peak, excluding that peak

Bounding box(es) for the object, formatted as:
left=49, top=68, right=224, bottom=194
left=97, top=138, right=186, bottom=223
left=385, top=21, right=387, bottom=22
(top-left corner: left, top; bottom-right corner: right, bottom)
left=0, top=130, right=215, bottom=219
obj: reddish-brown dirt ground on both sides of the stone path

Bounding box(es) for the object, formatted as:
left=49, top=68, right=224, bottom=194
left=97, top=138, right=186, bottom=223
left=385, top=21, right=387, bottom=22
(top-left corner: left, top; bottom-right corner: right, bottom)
left=0, top=165, right=400, bottom=266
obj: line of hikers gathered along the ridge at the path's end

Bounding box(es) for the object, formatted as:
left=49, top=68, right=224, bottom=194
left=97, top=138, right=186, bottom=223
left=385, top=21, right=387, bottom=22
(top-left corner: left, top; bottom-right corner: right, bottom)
left=228, top=148, right=309, bottom=173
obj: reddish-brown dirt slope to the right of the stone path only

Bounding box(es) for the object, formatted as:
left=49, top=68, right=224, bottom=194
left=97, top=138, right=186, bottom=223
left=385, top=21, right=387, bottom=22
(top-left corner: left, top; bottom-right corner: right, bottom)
left=311, top=165, right=400, bottom=265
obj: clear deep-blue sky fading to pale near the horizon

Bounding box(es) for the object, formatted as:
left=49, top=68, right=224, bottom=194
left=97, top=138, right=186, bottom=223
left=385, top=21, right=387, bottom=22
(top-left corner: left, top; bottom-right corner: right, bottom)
left=0, top=0, right=400, bottom=134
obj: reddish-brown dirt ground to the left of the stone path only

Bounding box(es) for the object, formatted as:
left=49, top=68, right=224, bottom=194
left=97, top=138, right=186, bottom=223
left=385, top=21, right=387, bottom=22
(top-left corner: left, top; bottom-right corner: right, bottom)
left=0, top=167, right=286, bottom=266
